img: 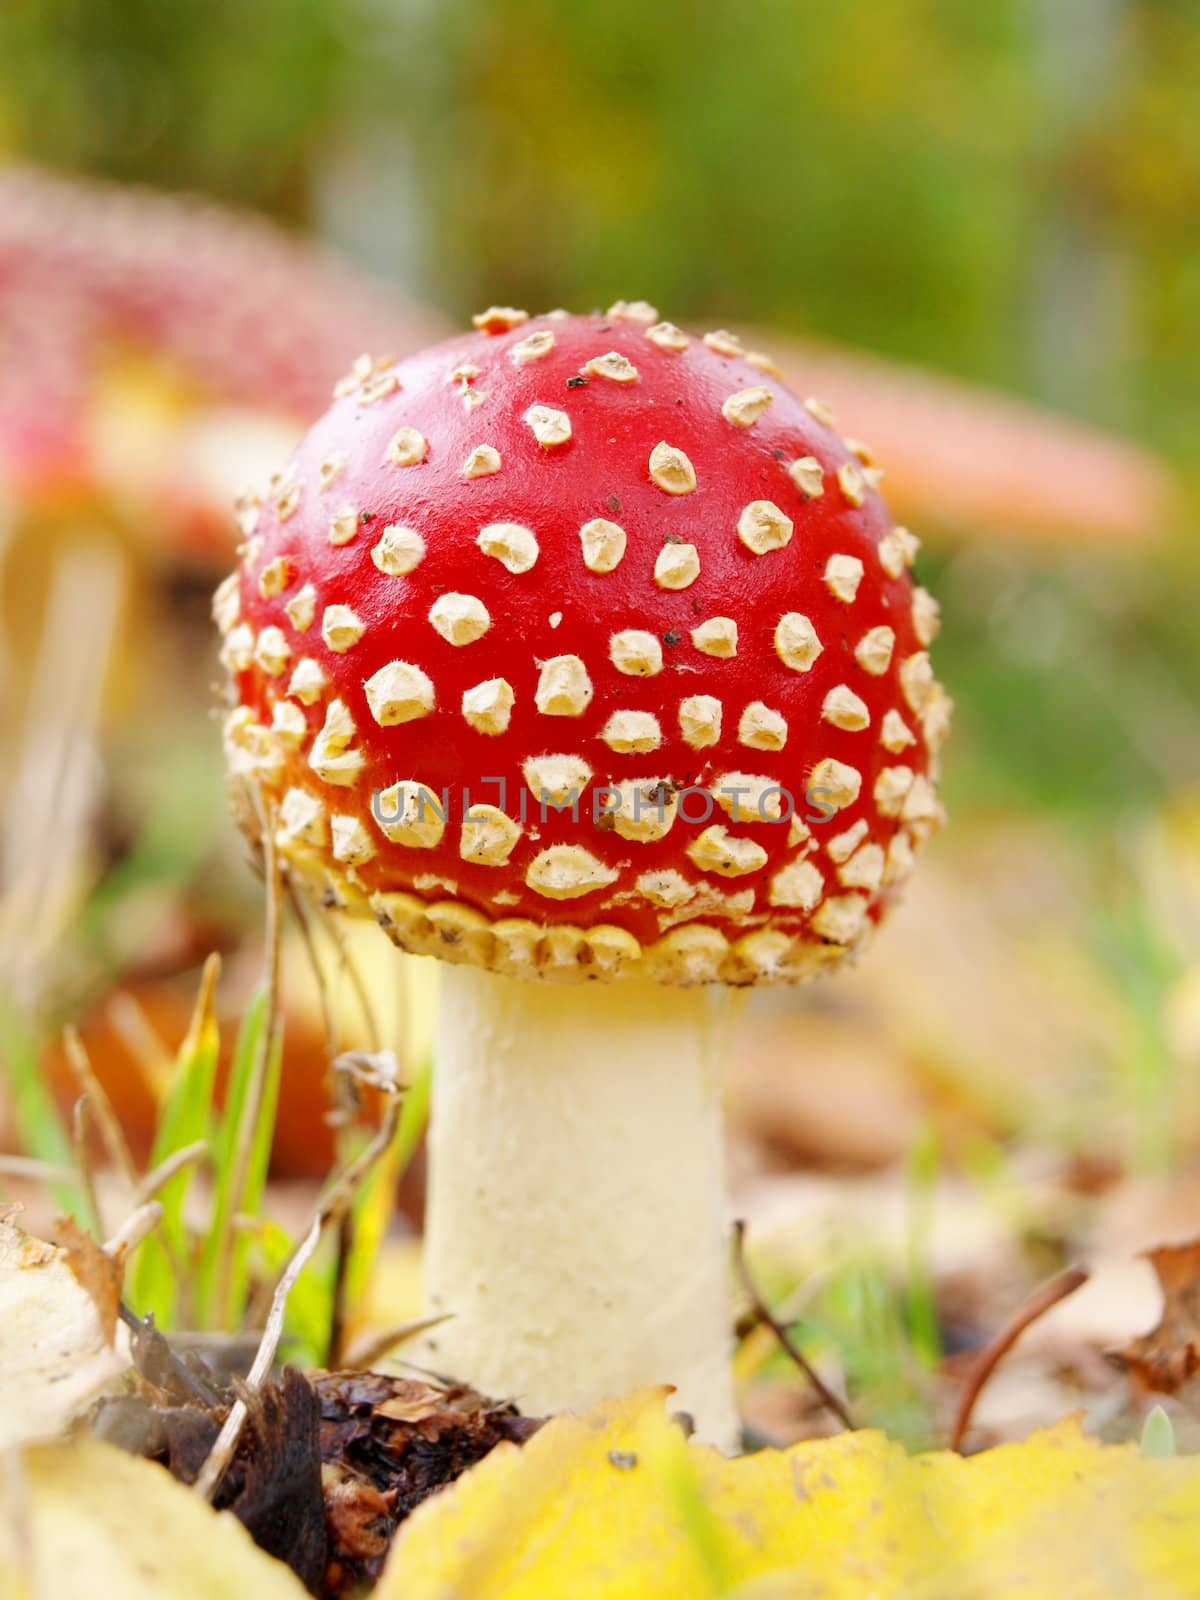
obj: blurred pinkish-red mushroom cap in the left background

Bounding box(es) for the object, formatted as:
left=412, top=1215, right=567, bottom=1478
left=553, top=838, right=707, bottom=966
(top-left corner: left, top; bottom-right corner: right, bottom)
left=0, top=166, right=440, bottom=537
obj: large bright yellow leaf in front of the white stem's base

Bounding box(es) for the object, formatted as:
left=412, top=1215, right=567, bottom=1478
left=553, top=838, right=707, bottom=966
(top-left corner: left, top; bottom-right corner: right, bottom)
left=378, top=1390, right=1200, bottom=1600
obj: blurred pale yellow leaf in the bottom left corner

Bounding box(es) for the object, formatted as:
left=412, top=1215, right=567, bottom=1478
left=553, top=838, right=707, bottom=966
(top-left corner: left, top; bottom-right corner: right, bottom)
left=0, top=1438, right=306, bottom=1600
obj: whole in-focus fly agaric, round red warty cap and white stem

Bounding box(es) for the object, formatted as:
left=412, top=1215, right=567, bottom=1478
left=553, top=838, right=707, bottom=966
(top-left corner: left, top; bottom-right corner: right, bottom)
left=216, top=304, right=949, bottom=1446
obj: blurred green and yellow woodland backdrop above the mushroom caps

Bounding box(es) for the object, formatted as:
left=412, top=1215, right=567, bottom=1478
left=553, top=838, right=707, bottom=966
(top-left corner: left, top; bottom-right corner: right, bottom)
left=0, top=0, right=1200, bottom=454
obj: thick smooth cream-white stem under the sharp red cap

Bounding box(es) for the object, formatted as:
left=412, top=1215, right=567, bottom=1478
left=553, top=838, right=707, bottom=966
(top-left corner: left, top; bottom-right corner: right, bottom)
left=422, top=966, right=738, bottom=1450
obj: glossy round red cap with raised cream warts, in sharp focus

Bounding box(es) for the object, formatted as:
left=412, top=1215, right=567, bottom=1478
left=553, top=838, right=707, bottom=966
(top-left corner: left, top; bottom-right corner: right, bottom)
left=216, top=304, right=949, bottom=982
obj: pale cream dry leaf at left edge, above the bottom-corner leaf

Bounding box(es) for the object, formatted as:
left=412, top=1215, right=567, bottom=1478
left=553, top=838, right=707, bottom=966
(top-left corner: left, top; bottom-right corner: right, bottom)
left=0, top=1213, right=130, bottom=1450
